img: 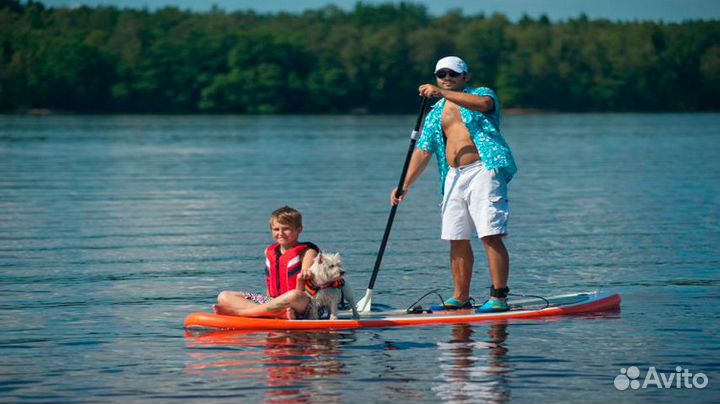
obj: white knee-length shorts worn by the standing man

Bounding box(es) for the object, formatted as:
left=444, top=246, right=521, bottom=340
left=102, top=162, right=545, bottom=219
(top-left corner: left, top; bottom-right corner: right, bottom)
left=440, top=161, right=510, bottom=240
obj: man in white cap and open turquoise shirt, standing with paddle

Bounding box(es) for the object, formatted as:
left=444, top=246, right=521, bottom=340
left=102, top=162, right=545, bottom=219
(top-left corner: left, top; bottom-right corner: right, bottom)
left=390, top=56, right=517, bottom=313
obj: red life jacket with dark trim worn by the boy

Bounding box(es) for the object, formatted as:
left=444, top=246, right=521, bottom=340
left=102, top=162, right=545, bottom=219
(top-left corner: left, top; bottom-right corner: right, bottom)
left=265, top=243, right=319, bottom=297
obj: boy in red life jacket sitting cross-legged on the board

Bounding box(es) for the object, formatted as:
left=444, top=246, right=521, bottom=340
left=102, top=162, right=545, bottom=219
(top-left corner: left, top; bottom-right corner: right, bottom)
left=213, top=206, right=320, bottom=320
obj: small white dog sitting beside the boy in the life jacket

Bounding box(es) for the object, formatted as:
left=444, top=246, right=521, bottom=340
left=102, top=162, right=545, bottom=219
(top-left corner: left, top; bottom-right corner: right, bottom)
left=305, top=254, right=359, bottom=320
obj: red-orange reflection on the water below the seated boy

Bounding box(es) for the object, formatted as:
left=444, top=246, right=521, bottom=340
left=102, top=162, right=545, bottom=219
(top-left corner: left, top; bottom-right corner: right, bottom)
left=185, top=331, right=353, bottom=403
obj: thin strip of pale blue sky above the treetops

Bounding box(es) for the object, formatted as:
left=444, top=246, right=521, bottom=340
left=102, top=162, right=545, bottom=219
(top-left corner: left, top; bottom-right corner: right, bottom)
left=42, top=0, right=720, bottom=22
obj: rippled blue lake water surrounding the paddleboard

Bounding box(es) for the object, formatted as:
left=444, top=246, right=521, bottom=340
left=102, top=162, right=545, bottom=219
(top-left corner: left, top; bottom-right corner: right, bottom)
left=0, top=114, right=720, bottom=403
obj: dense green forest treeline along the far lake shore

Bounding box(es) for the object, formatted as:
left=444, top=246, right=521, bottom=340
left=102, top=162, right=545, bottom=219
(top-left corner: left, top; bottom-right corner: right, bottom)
left=0, top=0, right=720, bottom=113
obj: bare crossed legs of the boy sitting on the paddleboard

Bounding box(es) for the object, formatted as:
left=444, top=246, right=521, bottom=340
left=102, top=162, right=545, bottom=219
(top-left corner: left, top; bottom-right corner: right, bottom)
left=218, top=290, right=310, bottom=318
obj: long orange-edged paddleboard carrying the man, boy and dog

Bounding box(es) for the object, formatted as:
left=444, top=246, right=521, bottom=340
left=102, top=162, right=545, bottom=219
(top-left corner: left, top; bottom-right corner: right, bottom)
left=185, top=292, right=621, bottom=330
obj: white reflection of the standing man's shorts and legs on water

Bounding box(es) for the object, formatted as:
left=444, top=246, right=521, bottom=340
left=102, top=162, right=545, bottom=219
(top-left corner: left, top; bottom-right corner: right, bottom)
left=433, top=322, right=511, bottom=403
